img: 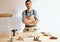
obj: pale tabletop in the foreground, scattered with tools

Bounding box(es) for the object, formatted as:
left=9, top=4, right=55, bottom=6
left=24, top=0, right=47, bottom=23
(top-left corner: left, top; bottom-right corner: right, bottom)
left=0, top=32, right=60, bottom=42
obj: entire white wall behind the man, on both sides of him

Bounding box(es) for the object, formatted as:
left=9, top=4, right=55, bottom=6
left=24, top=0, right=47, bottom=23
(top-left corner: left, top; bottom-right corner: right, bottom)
left=0, top=0, right=60, bottom=32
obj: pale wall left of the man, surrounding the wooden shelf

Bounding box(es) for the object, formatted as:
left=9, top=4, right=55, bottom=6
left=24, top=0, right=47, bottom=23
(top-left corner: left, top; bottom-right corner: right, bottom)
left=0, top=0, right=25, bottom=32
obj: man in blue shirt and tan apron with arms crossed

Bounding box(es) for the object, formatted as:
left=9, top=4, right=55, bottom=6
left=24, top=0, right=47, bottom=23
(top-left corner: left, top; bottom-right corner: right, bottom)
left=22, top=0, right=38, bottom=32
